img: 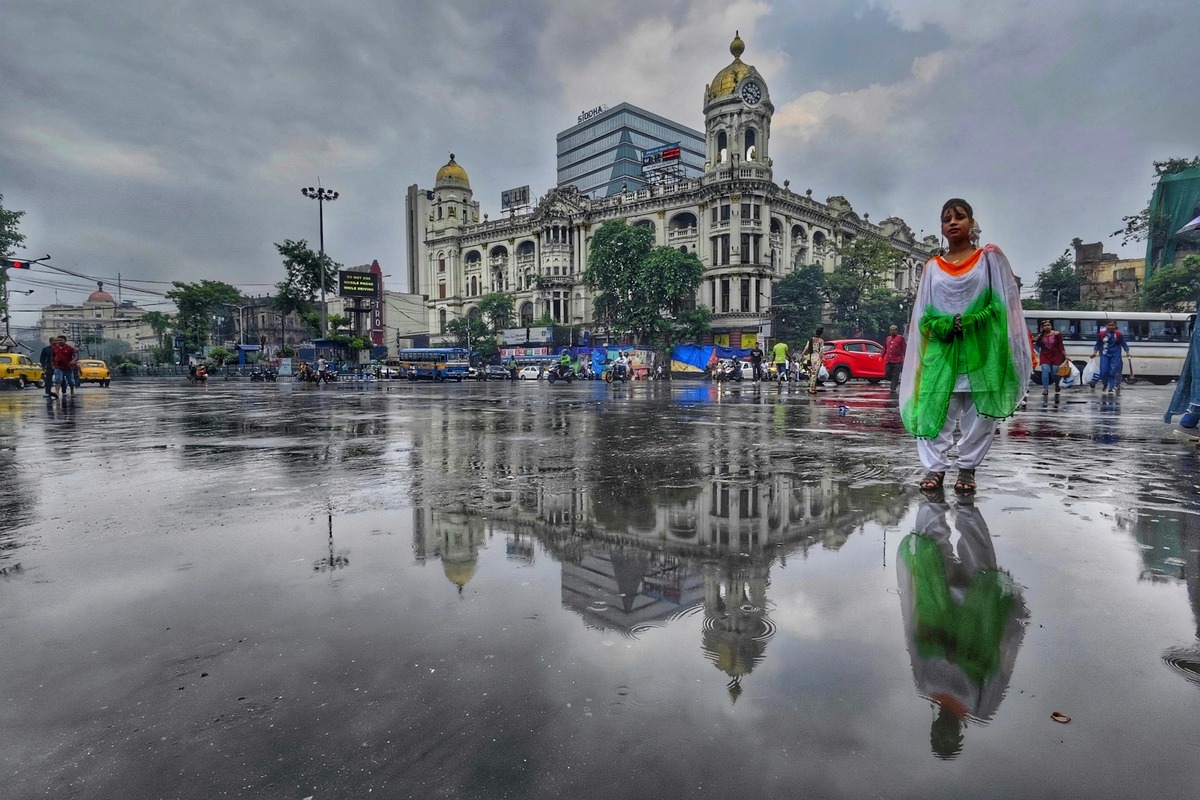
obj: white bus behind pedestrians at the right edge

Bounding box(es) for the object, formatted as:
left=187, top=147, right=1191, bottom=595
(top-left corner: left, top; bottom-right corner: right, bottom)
left=1025, top=308, right=1195, bottom=384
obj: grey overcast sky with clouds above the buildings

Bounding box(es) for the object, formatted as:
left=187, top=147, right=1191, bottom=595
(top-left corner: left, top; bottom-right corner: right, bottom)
left=0, top=0, right=1200, bottom=324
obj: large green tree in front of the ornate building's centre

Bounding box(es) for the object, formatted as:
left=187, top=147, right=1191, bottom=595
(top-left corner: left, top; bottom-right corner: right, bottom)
left=583, top=221, right=704, bottom=343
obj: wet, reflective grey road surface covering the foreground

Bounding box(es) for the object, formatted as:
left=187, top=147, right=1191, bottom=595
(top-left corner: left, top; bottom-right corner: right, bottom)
left=0, top=381, right=1200, bottom=798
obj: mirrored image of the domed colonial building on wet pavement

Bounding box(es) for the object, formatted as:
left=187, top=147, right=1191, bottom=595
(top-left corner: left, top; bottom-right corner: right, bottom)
left=414, top=424, right=907, bottom=700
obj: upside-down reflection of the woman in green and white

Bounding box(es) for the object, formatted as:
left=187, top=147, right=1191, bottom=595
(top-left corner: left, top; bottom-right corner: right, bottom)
left=896, top=493, right=1028, bottom=759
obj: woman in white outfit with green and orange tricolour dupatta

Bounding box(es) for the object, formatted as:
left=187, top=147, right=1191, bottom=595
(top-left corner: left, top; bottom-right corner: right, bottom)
left=899, top=198, right=1032, bottom=493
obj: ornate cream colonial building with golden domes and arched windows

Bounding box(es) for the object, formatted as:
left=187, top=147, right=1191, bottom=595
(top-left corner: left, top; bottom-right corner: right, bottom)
left=408, top=37, right=937, bottom=347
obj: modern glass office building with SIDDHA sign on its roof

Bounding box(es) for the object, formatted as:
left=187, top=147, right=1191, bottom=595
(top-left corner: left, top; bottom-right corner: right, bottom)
left=557, top=103, right=704, bottom=197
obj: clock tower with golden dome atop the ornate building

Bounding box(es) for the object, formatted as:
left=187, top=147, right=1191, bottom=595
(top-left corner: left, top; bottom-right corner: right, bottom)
left=704, top=34, right=775, bottom=180
